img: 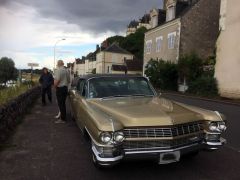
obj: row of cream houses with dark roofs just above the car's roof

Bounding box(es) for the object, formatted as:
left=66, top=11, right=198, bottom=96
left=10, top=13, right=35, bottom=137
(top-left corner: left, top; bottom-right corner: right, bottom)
left=71, top=43, right=143, bottom=76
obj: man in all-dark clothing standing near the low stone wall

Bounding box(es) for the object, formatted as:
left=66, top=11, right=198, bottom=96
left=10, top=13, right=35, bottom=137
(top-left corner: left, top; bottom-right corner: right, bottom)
left=39, top=68, right=53, bottom=106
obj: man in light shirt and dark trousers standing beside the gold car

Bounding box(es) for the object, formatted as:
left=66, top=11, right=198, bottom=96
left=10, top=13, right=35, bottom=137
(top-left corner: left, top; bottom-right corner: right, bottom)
left=54, top=60, right=70, bottom=123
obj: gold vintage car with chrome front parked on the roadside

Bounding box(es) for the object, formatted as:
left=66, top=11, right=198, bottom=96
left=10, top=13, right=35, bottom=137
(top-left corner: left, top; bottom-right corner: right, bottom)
left=70, top=75, right=226, bottom=167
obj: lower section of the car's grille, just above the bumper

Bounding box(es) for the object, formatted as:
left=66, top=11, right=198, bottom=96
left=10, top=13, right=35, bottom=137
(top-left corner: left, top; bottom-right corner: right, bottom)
left=123, top=133, right=204, bottom=152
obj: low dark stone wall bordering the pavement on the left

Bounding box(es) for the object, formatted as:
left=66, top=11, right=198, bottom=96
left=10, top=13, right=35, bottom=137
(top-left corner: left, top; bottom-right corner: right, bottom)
left=0, top=86, right=41, bottom=142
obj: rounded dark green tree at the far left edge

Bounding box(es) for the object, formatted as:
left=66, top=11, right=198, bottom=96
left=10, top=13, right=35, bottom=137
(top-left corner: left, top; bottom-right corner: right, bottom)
left=0, top=57, right=18, bottom=84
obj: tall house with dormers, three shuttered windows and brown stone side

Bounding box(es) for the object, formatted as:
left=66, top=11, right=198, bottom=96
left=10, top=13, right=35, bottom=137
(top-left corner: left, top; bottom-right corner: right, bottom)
left=144, top=0, right=220, bottom=70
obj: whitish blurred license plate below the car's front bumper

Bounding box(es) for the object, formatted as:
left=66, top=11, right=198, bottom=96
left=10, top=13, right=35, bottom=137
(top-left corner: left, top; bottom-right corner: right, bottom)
left=159, top=151, right=181, bottom=164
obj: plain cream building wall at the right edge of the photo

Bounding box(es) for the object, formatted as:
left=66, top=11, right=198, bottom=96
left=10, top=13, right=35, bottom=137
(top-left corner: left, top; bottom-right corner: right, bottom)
left=215, top=0, right=240, bottom=99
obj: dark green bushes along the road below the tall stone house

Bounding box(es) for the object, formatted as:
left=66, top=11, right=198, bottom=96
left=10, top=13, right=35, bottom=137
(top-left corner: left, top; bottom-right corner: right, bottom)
left=145, top=52, right=218, bottom=96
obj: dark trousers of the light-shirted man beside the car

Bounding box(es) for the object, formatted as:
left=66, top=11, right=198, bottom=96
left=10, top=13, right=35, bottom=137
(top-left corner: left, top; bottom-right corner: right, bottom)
left=56, top=86, right=68, bottom=121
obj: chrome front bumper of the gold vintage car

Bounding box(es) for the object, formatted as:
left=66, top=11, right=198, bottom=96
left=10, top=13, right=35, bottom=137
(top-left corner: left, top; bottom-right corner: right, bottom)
left=92, top=138, right=226, bottom=165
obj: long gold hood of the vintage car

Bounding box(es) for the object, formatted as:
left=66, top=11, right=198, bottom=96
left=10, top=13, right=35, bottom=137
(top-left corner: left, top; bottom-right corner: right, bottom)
left=88, top=97, right=220, bottom=127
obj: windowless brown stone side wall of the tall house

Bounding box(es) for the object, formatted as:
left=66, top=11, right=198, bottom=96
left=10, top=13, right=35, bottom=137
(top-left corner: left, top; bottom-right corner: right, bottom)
left=180, top=0, right=220, bottom=59
